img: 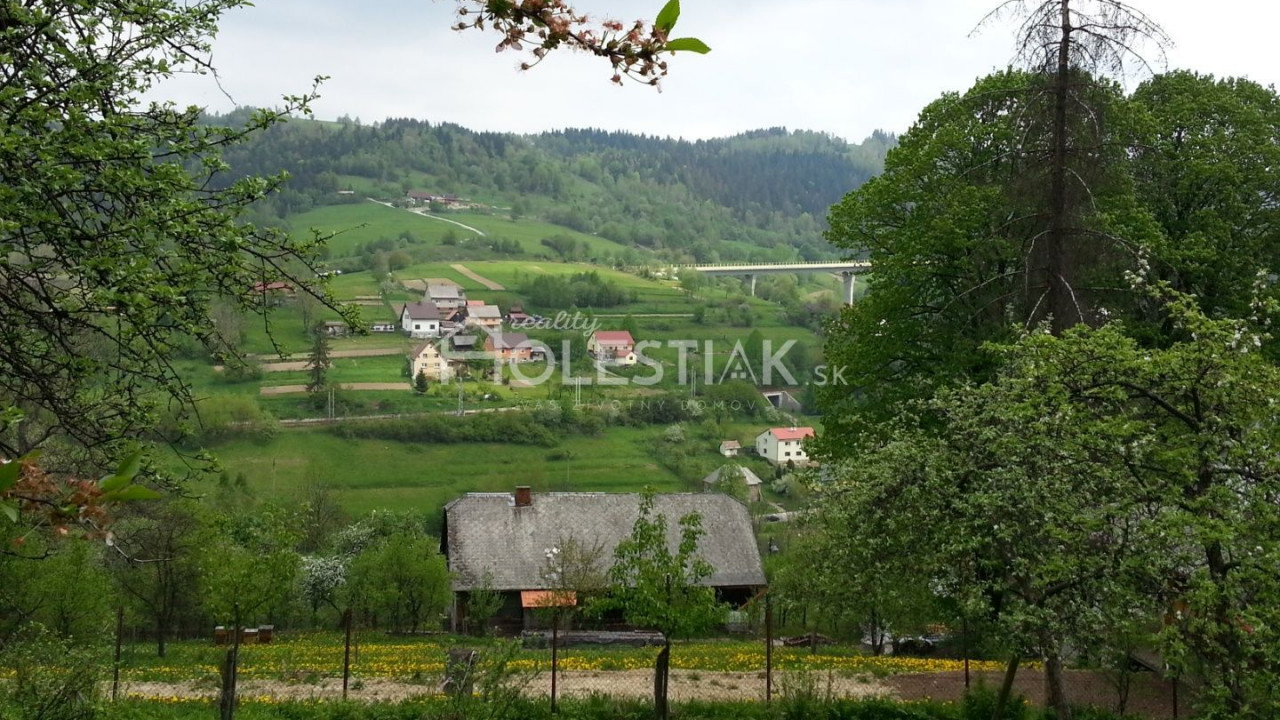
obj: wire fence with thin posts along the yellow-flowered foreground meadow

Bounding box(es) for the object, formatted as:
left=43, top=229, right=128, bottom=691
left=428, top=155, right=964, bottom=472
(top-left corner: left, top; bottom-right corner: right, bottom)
left=104, top=599, right=1192, bottom=720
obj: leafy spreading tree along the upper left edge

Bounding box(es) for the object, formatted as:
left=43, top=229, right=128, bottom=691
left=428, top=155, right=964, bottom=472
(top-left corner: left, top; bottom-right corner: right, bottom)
left=0, top=0, right=353, bottom=461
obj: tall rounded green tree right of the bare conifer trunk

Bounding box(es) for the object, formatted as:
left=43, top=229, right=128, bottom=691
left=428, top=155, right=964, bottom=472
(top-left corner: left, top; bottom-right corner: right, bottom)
left=1130, top=72, right=1280, bottom=327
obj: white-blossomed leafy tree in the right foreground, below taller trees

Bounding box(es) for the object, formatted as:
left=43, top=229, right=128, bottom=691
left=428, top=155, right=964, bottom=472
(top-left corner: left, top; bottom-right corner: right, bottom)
left=828, top=288, right=1280, bottom=717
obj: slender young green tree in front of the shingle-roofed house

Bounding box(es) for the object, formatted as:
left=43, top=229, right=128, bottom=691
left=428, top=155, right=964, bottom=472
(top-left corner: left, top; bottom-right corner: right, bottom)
left=593, top=491, right=728, bottom=717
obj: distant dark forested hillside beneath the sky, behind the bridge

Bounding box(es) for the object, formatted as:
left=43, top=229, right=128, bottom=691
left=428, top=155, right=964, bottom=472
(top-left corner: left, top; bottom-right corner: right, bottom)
left=209, top=110, right=896, bottom=261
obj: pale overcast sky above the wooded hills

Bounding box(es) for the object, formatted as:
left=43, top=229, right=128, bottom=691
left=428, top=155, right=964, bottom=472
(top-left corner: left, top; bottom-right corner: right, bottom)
left=148, top=0, right=1280, bottom=141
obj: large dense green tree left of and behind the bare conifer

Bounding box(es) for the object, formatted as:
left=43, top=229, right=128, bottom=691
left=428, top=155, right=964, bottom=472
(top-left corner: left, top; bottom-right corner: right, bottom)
left=819, top=72, right=1158, bottom=438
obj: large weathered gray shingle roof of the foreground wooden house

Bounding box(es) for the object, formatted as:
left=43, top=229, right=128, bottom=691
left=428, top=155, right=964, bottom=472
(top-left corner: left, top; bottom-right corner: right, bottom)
left=444, top=492, right=765, bottom=591
